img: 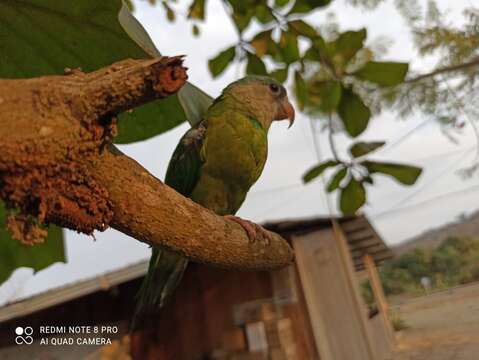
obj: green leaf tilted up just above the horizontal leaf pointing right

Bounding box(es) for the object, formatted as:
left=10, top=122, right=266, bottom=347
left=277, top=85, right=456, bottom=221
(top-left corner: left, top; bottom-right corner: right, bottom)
left=327, top=29, right=367, bottom=69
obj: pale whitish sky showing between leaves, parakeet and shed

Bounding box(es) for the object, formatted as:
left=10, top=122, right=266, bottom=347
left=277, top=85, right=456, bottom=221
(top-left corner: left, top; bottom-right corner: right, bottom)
left=0, top=0, right=479, bottom=305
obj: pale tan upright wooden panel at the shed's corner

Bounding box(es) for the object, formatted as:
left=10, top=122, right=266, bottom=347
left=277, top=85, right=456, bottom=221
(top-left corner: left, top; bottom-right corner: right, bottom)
left=293, top=229, right=374, bottom=360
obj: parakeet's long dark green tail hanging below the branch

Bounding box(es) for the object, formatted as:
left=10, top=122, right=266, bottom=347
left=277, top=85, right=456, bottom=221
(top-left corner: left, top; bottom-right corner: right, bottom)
left=131, top=247, right=188, bottom=330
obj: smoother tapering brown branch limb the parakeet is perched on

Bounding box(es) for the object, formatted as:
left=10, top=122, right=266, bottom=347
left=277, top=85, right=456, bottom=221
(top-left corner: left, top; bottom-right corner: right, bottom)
left=95, top=147, right=293, bottom=270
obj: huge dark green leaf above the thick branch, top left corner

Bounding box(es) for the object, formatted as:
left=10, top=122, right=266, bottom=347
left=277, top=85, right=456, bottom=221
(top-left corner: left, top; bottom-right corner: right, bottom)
left=0, top=0, right=147, bottom=78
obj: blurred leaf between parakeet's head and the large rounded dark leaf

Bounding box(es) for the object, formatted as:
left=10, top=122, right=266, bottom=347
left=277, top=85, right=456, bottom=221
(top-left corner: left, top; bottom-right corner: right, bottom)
left=308, top=80, right=342, bottom=114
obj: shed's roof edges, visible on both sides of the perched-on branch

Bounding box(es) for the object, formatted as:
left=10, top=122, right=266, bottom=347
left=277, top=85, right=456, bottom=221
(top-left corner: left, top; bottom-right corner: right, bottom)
left=0, top=216, right=393, bottom=322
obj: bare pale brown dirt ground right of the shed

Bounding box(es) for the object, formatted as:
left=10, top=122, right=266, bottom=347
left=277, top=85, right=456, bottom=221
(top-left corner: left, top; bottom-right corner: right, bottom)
left=391, top=283, right=479, bottom=360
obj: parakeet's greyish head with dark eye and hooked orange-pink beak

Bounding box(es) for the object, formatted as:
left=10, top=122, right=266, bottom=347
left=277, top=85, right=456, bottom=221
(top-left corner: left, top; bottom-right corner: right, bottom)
left=223, top=76, right=294, bottom=129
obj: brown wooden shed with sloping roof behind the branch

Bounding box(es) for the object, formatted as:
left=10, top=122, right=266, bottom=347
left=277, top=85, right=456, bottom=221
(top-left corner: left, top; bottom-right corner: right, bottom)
left=0, top=216, right=393, bottom=360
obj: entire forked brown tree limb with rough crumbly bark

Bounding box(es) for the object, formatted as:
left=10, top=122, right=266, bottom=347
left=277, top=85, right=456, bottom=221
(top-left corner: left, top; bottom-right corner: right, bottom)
left=0, top=57, right=292, bottom=269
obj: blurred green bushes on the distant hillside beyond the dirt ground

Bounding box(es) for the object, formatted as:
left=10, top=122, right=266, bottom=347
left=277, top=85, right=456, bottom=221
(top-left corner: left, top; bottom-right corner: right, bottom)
left=361, top=237, right=479, bottom=305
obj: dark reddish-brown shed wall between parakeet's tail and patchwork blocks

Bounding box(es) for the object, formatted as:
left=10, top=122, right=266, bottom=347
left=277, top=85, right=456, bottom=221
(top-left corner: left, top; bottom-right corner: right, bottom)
left=132, top=264, right=272, bottom=360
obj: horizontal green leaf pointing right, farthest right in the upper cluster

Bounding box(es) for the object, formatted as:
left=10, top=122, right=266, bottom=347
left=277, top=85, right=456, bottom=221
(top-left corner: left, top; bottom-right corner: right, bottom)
left=353, top=61, right=409, bottom=86
